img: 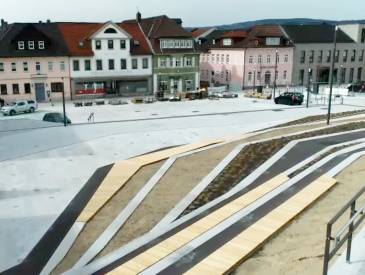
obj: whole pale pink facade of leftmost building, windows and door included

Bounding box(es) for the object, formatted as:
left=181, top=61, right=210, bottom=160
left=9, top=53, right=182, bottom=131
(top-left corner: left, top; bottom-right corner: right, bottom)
left=0, top=57, right=71, bottom=103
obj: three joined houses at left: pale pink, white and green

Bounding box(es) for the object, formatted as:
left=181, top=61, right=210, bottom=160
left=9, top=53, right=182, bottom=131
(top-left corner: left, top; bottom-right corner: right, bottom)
left=0, top=13, right=200, bottom=102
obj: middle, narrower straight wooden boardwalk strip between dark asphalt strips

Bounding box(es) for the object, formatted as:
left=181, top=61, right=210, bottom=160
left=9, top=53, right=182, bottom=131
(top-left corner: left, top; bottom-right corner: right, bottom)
left=108, top=174, right=289, bottom=275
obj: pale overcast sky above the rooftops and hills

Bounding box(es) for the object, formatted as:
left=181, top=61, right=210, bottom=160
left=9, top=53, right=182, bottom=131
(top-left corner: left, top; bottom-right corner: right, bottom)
left=0, top=0, right=365, bottom=27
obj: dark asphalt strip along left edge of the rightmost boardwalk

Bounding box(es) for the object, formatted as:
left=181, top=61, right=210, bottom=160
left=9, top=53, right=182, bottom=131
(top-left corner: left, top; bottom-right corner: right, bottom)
left=158, top=149, right=364, bottom=275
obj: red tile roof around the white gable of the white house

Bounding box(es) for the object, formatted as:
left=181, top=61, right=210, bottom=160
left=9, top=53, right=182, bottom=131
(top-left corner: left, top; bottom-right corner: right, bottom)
left=58, top=22, right=152, bottom=56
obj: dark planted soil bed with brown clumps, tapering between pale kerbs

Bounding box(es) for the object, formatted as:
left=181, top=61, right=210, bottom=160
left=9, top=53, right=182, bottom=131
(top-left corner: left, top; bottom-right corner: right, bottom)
left=180, top=122, right=365, bottom=217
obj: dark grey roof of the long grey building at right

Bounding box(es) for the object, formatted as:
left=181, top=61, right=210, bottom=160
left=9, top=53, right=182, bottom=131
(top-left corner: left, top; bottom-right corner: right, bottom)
left=282, top=24, right=355, bottom=44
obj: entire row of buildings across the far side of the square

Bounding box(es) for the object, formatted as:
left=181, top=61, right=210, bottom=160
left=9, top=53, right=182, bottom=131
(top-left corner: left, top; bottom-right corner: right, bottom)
left=0, top=13, right=365, bottom=101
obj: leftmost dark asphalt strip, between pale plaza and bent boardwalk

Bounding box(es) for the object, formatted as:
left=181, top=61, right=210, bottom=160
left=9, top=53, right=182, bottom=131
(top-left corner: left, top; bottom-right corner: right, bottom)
left=0, top=164, right=113, bottom=275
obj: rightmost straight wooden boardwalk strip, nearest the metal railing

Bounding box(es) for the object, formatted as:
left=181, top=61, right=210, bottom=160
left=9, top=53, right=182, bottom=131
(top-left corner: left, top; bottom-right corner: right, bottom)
left=185, top=176, right=336, bottom=275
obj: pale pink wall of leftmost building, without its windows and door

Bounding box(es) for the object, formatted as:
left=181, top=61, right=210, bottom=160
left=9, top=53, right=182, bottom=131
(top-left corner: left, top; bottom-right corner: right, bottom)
left=0, top=57, right=70, bottom=102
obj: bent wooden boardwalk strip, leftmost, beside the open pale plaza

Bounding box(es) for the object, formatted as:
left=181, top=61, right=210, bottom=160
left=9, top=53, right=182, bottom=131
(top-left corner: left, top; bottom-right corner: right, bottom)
left=77, top=140, right=223, bottom=223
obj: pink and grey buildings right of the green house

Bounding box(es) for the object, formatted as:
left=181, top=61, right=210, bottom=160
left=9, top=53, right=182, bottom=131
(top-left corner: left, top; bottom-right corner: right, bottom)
left=193, top=24, right=365, bottom=90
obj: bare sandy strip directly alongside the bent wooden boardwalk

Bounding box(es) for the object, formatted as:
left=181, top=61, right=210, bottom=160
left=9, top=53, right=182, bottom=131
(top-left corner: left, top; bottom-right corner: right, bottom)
left=52, top=162, right=162, bottom=274
